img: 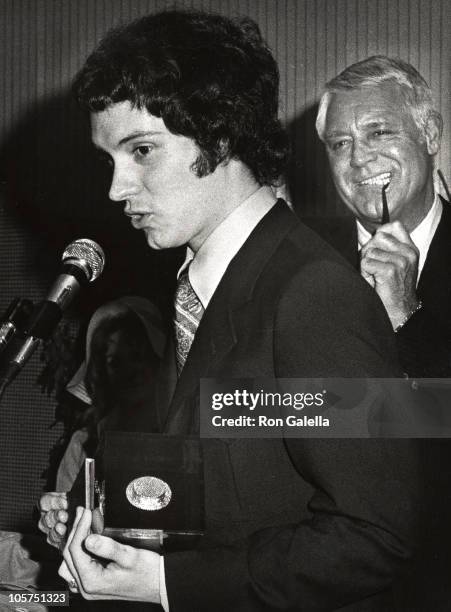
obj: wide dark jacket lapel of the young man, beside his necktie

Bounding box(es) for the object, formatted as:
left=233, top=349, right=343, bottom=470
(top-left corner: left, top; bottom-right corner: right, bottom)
left=164, top=200, right=298, bottom=434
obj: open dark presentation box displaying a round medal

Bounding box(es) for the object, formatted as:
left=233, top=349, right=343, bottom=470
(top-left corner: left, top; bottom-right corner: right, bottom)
left=97, top=431, right=204, bottom=552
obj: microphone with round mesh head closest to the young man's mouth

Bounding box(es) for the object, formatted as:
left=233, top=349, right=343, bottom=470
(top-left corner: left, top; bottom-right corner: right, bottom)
left=0, top=238, right=105, bottom=397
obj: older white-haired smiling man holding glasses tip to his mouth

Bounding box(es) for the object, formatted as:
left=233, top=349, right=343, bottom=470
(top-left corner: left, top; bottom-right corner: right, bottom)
left=315, top=56, right=451, bottom=377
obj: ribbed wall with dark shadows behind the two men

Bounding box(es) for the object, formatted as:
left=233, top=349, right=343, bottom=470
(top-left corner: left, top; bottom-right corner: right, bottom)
left=0, top=0, right=451, bottom=529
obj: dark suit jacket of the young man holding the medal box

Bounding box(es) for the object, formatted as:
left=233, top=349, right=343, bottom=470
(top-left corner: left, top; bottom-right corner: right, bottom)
left=160, top=201, right=418, bottom=612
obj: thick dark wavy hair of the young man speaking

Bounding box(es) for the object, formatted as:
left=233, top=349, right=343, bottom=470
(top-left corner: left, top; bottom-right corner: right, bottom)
left=73, top=10, right=288, bottom=184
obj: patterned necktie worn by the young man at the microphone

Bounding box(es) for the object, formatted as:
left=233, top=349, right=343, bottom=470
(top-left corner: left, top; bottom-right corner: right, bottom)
left=174, top=269, right=204, bottom=376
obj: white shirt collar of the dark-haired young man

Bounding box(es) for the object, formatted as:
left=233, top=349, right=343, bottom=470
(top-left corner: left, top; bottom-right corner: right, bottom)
left=178, top=186, right=277, bottom=308
